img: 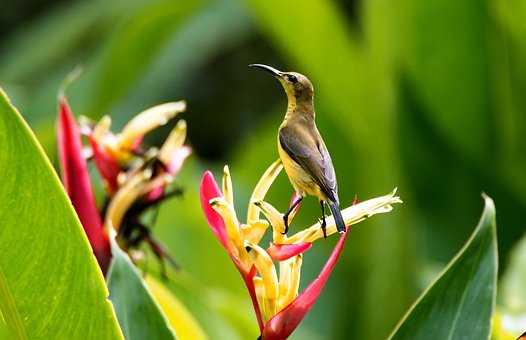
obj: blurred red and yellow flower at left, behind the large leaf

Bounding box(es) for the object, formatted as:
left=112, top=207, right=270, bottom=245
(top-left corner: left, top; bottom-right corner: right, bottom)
left=58, top=96, right=191, bottom=273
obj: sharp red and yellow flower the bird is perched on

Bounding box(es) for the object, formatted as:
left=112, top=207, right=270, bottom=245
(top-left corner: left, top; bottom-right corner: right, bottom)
left=201, top=160, right=402, bottom=340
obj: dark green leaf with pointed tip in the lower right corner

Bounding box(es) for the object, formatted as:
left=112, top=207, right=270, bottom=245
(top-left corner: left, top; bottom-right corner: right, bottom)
left=390, top=196, right=497, bottom=340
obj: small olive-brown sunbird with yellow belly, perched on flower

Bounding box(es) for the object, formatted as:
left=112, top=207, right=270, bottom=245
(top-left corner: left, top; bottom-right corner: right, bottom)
left=249, top=64, right=346, bottom=237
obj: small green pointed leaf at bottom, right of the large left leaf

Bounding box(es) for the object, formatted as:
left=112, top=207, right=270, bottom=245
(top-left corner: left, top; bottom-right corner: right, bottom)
left=108, top=240, right=175, bottom=340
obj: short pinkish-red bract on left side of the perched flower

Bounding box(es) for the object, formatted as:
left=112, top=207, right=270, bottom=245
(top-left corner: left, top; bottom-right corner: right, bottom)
left=200, top=171, right=230, bottom=250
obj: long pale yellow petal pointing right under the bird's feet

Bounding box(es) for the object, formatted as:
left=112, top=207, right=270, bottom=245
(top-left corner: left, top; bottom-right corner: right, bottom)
left=285, top=189, right=402, bottom=243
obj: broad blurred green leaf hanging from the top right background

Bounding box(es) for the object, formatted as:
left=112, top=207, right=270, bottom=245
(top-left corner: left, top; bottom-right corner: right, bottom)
left=398, top=0, right=500, bottom=164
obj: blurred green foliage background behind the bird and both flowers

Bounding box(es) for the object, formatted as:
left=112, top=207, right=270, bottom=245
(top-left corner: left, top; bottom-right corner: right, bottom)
left=0, top=0, right=526, bottom=339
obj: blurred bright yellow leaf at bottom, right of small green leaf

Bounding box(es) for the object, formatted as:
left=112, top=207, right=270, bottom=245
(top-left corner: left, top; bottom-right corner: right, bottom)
left=145, top=275, right=208, bottom=340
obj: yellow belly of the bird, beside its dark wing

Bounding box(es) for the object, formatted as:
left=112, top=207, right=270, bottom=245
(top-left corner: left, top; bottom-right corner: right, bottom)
left=278, top=141, right=326, bottom=200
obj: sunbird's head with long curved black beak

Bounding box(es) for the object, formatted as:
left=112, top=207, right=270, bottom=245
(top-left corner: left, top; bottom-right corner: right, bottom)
left=248, top=64, right=314, bottom=106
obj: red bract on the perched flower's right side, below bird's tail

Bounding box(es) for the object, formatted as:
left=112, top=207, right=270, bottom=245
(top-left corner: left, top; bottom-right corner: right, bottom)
left=262, top=232, right=349, bottom=340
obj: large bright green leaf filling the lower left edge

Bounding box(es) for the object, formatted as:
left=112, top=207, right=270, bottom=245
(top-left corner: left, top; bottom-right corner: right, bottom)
left=0, top=89, right=122, bottom=339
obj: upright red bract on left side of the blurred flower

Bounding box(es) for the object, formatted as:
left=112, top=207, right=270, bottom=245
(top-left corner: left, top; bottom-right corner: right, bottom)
left=58, top=97, right=111, bottom=273
